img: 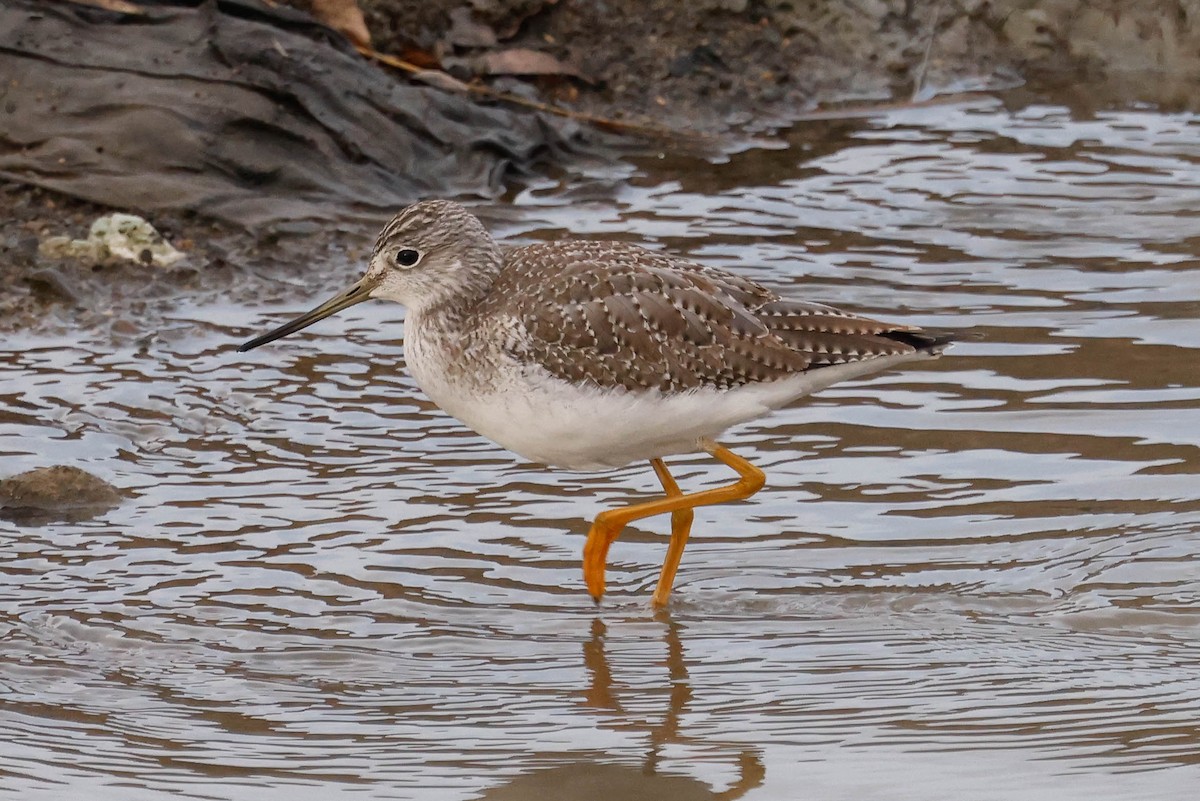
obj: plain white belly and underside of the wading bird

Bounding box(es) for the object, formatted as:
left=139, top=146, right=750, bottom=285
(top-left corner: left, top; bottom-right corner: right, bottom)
left=408, top=333, right=913, bottom=470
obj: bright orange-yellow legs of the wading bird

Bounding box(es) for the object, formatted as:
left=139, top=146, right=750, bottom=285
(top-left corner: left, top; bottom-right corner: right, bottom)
left=583, top=440, right=767, bottom=604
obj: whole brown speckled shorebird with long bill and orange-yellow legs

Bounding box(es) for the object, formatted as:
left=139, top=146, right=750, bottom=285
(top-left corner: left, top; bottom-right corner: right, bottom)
left=239, top=200, right=952, bottom=606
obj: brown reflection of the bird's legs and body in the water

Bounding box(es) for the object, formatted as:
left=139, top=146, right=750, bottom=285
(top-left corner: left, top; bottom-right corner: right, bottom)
left=476, top=619, right=766, bottom=801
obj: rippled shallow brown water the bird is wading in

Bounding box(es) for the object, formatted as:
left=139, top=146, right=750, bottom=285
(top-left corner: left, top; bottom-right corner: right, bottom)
left=7, top=101, right=1200, bottom=801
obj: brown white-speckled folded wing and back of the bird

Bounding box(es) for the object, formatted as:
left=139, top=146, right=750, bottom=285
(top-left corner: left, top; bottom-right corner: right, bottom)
left=488, top=241, right=942, bottom=392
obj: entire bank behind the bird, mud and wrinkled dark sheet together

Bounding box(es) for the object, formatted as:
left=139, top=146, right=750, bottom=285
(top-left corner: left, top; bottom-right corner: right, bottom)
left=0, top=0, right=1200, bottom=339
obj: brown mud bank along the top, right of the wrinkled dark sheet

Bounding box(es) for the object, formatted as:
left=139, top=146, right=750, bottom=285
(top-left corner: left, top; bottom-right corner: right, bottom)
left=355, top=0, right=1200, bottom=131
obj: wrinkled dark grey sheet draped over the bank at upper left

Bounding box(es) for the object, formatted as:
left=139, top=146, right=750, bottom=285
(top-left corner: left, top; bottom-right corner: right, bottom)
left=0, top=0, right=572, bottom=225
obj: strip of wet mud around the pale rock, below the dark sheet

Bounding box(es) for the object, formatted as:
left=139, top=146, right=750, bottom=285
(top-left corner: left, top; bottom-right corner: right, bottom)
left=0, top=182, right=370, bottom=345
